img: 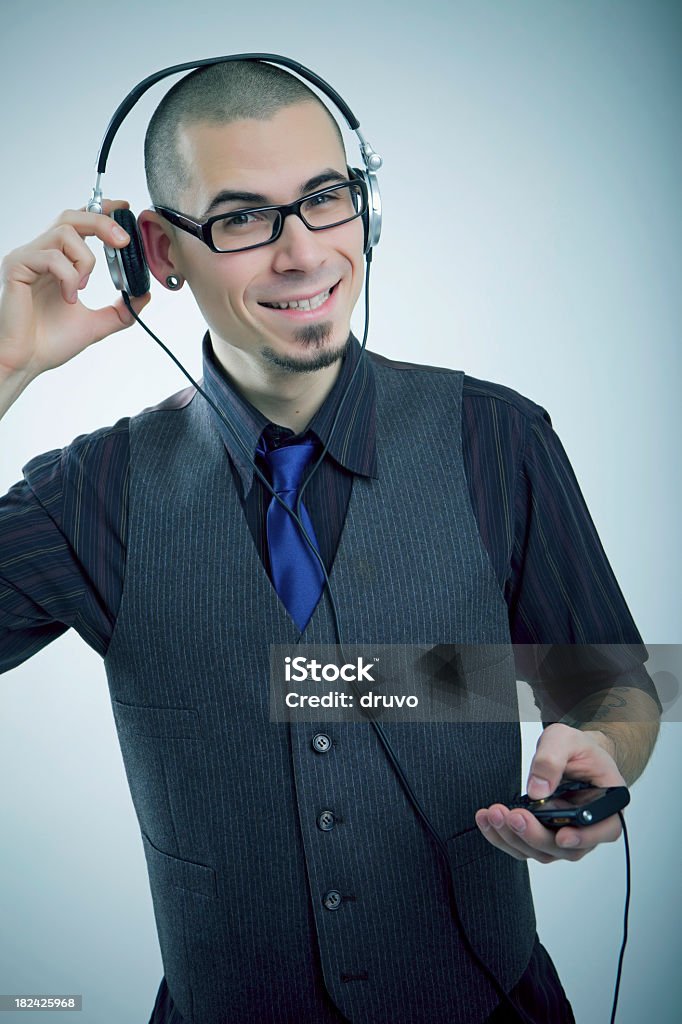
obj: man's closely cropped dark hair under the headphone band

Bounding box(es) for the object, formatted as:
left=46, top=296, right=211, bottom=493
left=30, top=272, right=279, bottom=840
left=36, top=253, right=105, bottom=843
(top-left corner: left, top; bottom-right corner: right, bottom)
left=144, top=60, right=345, bottom=207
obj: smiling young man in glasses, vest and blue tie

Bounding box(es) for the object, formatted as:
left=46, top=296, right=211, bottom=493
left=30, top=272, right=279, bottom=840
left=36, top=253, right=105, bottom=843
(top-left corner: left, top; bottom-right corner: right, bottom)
left=0, top=63, right=658, bottom=1024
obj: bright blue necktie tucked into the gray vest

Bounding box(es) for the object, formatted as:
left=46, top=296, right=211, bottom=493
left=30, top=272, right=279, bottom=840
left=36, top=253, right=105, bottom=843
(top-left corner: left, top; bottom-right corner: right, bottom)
left=258, top=438, right=325, bottom=632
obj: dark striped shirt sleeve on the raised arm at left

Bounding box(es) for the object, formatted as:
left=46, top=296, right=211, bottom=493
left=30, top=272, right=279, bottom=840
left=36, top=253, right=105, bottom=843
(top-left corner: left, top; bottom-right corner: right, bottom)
left=0, top=420, right=128, bottom=673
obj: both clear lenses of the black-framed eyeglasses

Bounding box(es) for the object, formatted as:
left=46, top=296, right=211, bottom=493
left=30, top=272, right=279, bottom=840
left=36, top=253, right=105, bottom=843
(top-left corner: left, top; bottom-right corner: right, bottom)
left=211, top=182, right=364, bottom=252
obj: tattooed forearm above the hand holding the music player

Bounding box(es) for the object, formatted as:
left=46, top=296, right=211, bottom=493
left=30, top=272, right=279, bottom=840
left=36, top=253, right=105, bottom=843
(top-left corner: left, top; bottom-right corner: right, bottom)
left=561, top=686, right=660, bottom=785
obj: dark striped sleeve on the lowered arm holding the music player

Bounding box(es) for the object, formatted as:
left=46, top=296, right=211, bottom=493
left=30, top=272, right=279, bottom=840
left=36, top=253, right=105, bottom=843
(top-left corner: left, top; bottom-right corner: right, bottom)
left=506, top=407, right=660, bottom=721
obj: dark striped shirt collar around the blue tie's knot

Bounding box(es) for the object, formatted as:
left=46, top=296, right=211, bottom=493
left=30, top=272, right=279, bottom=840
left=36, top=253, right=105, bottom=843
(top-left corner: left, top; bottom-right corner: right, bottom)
left=202, top=331, right=377, bottom=497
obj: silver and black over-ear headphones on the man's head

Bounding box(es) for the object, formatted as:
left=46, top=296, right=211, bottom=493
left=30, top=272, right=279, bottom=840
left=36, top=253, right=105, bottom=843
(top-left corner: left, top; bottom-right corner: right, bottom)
left=86, top=53, right=383, bottom=296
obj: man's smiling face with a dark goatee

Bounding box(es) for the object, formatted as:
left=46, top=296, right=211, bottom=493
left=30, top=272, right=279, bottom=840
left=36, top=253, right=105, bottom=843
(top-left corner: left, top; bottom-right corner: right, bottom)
left=166, top=102, right=364, bottom=372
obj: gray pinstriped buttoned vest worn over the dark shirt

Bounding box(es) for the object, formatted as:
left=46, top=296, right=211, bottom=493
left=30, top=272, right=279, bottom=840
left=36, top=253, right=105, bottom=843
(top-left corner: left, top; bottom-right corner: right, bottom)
left=105, top=354, right=535, bottom=1024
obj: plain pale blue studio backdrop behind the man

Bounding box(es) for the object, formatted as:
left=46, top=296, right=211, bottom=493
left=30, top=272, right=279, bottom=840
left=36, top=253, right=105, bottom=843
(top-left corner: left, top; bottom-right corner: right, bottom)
left=0, top=0, right=682, bottom=1024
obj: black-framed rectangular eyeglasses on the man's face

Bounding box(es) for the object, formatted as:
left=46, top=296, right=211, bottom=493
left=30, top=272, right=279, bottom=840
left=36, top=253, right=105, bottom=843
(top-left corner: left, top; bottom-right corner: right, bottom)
left=154, top=178, right=368, bottom=253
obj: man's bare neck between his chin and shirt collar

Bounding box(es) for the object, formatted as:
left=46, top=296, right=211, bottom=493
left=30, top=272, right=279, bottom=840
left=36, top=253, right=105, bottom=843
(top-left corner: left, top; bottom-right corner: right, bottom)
left=211, top=334, right=345, bottom=433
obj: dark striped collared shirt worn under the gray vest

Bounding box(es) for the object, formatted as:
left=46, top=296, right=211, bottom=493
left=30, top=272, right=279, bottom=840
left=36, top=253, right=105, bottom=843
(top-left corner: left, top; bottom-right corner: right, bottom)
left=0, top=335, right=648, bottom=1024
